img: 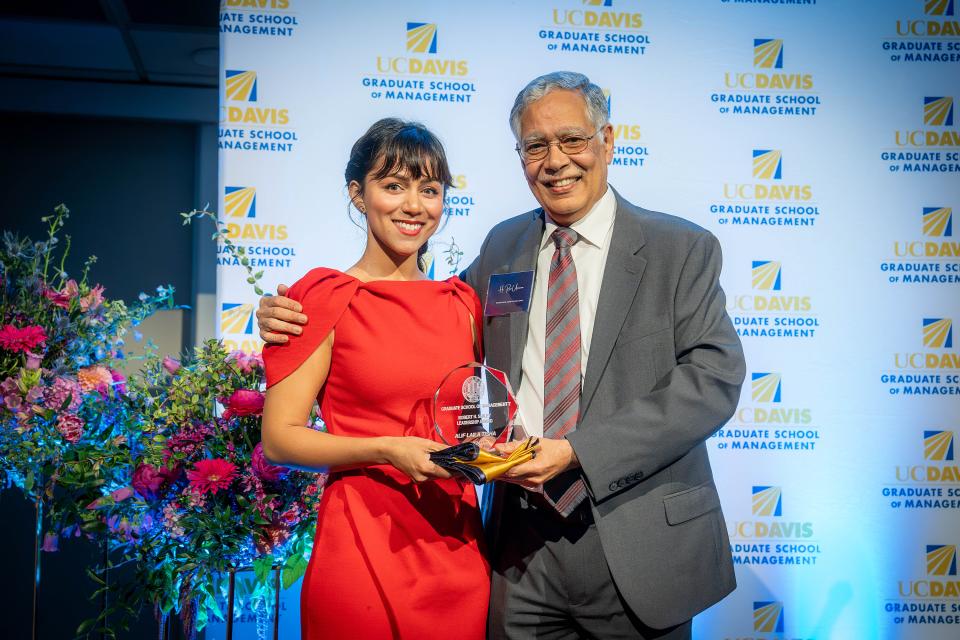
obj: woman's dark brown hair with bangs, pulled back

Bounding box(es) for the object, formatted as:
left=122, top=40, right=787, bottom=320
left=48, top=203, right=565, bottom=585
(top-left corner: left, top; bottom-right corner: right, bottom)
left=343, top=118, right=453, bottom=189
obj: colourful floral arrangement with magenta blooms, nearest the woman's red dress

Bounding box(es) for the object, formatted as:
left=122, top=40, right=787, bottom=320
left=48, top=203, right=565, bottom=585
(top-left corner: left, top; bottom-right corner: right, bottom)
left=91, top=341, right=322, bottom=637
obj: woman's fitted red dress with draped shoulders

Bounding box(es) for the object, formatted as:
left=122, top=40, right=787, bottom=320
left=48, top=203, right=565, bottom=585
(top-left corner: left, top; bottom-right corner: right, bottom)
left=264, top=269, right=490, bottom=640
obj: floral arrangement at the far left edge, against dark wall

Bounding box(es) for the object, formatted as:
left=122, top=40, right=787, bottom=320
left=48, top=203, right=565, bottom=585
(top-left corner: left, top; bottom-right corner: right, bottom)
left=0, top=205, right=173, bottom=550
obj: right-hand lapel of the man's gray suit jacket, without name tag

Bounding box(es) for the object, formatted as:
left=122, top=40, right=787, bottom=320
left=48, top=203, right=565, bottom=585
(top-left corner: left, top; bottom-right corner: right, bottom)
left=580, top=196, right=647, bottom=417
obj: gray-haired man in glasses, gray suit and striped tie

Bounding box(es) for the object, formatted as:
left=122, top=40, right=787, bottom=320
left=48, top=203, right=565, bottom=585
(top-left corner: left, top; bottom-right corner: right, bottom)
left=258, top=72, right=744, bottom=638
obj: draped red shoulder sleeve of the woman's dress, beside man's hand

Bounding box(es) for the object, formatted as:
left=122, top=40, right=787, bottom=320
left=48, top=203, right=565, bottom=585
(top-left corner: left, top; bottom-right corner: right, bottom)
left=263, top=267, right=359, bottom=387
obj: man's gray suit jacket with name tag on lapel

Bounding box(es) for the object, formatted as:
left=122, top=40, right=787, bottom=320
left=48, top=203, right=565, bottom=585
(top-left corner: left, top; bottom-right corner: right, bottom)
left=463, top=194, right=745, bottom=628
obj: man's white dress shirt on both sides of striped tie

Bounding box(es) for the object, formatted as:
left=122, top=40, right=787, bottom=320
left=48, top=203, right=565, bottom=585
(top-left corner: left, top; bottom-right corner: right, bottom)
left=517, top=186, right=617, bottom=436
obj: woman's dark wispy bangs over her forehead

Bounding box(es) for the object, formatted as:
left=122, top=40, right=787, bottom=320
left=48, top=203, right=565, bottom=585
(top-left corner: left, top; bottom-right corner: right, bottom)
left=371, top=126, right=453, bottom=187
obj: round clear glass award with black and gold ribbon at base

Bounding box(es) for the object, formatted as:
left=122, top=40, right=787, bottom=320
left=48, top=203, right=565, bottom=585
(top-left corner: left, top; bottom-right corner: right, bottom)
left=430, top=362, right=537, bottom=484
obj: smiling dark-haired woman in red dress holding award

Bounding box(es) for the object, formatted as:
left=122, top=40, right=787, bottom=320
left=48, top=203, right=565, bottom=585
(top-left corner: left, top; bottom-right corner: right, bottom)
left=263, top=118, right=490, bottom=639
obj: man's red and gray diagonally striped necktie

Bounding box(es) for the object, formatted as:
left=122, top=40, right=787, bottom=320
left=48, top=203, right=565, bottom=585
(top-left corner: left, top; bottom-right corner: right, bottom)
left=543, top=227, right=586, bottom=516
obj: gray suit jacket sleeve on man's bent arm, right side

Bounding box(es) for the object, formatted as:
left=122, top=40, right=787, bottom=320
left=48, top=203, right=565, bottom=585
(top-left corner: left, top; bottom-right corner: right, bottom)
left=567, top=232, right=745, bottom=502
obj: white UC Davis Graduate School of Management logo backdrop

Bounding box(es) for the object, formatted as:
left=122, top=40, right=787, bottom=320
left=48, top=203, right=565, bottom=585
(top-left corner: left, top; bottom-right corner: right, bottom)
left=214, top=0, right=960, bottom=639
